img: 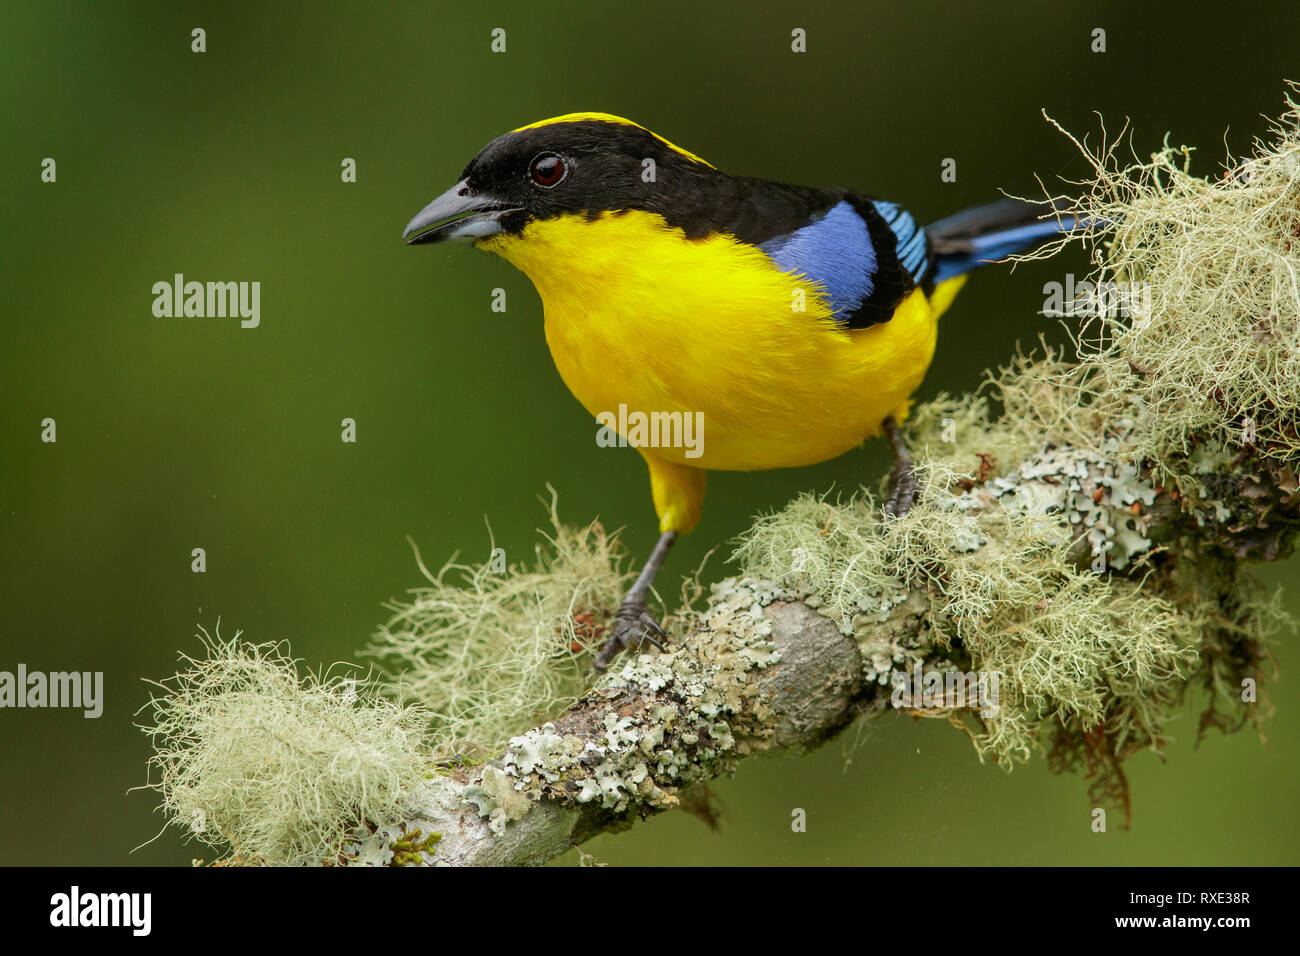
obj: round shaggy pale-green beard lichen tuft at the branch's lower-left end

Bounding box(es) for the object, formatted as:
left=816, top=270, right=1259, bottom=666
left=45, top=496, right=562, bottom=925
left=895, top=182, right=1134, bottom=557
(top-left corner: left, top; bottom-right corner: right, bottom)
left=143, top=631, right=428, bottom=865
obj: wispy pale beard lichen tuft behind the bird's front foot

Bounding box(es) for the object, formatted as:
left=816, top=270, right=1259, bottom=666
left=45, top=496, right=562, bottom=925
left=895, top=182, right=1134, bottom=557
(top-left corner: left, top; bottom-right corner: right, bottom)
left=363, top=490, right=629, bottom=760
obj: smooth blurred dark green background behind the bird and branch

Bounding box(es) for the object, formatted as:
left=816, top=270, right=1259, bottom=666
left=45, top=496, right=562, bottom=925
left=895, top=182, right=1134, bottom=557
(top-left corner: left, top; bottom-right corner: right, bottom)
left=0, top=0, right=1300, bottom=864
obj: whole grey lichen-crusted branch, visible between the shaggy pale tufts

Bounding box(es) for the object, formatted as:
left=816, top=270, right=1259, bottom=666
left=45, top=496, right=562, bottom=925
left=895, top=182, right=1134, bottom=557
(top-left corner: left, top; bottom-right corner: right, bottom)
left=379, top=429, right=1300, bottom=865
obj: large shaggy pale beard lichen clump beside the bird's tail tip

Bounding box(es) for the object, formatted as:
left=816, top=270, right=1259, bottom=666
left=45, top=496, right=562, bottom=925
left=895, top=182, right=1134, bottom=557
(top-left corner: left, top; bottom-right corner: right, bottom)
left=1008, top=85, right=1300, bottom=466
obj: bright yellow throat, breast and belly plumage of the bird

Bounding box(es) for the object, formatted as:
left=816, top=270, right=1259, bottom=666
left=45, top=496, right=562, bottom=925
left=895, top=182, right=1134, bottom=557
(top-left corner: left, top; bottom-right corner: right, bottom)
left=478, top=212, right=956, bottom=471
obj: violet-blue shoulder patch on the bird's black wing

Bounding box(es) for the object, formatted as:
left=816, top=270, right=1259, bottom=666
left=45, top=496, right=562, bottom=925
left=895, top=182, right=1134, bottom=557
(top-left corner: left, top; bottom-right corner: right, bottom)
left=758, top=202, right=878, bottom=321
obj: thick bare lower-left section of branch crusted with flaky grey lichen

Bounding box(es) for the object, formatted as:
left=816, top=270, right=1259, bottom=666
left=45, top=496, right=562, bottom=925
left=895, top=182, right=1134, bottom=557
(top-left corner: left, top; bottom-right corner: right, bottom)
left=413, top=590, right=889, bottom=865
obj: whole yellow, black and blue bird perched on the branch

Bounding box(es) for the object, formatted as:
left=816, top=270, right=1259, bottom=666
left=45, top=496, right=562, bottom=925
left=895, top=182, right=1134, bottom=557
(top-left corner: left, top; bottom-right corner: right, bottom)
left=402, top=112, right=1075, bottom=672
